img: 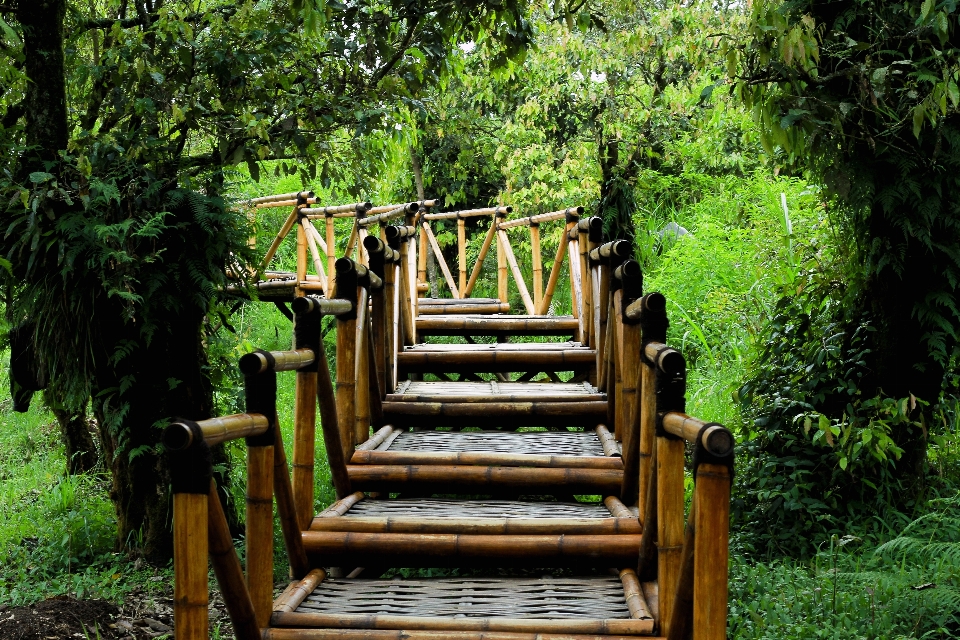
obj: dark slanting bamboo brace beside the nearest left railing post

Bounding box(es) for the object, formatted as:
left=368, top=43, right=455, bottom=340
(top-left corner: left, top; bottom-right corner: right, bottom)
left=205, top=479, right=260, bottom=640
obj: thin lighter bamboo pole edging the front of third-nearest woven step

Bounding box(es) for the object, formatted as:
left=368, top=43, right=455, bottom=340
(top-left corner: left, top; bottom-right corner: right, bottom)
left=350, top=450, right=623, bottom=469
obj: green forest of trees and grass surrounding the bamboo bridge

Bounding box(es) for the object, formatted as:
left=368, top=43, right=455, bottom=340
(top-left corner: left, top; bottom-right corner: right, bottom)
left=0, top=0, right=960, bottom=639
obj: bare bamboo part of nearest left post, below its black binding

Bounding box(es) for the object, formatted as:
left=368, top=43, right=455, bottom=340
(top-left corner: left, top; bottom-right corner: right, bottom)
left=173, top=493, right=208, bottom=640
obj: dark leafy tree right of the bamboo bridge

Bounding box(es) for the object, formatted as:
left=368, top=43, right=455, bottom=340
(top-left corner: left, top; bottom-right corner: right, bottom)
left=725, top=0, right=960, bottom=552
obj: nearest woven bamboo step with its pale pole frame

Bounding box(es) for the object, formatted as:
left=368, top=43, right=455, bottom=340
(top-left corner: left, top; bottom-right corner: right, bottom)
left=274, top=569, right=656, bottom=640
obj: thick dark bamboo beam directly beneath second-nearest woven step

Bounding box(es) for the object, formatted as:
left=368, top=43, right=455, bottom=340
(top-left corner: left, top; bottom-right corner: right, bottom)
left=302, top=531, right=640, bottom=567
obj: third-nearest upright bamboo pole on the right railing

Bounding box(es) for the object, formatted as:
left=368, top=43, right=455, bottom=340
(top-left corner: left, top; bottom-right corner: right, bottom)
left=617, top=308, right=640, bottom=506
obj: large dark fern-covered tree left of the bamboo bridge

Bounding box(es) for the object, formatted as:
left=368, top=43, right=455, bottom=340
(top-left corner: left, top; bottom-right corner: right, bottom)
left=0, top=0, right=529, bottom=559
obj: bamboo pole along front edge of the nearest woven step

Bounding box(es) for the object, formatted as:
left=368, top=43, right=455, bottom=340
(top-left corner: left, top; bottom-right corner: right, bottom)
left=274, top=612, right=653, bottom=640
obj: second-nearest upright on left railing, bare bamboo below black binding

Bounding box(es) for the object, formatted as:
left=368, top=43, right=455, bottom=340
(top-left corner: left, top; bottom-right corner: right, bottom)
left=248, top=445, right=274, bottom=627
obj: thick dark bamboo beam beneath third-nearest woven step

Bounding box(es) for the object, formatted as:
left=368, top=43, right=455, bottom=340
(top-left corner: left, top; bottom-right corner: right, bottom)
left=347, top=464, right=623, bottom=495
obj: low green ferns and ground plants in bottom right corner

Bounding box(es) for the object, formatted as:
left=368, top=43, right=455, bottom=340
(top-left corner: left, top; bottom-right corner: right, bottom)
left=728, top=495, right=960, bottom=639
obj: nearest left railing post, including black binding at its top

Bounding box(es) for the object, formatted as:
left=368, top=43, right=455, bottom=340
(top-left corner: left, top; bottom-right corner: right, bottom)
left=170, top=442, right=212, bottom=640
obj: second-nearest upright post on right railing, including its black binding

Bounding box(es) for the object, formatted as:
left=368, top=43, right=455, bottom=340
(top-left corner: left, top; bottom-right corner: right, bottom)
left=657, top=348, right=686, bottom=635
